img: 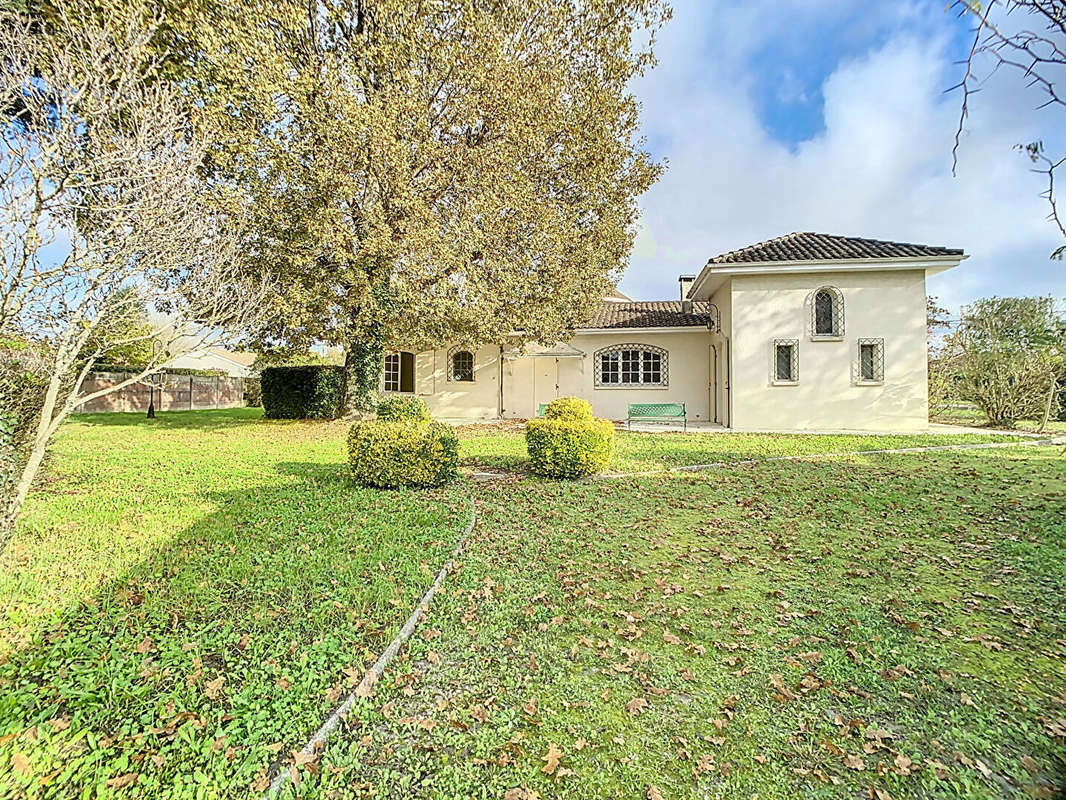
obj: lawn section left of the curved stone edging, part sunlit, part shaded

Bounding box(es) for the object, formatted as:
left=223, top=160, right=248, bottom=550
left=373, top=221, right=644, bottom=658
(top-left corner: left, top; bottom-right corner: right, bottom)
left=0, top=411, right=469, bottom=798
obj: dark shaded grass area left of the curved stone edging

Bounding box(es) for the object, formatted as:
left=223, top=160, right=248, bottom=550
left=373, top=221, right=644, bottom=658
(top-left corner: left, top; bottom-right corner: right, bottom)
left=0, top=460, right=468, bottom=797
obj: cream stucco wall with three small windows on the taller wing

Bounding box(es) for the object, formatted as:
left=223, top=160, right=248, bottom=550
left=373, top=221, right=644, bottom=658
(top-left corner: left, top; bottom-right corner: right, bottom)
left=730, top=270, right=928, bottom=430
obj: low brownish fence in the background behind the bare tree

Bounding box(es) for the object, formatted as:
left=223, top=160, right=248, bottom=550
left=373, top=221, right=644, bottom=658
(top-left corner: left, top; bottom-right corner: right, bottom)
left=75, top=372, right=244, bottom=414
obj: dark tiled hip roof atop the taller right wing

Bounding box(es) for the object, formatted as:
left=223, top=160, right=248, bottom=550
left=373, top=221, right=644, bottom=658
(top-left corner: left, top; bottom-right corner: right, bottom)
left=707, top=231, right=963, bottom=266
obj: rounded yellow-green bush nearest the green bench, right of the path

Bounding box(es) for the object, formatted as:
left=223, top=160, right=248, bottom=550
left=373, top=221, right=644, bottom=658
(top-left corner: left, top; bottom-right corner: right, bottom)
left=526, top=416, right=614, bottom=478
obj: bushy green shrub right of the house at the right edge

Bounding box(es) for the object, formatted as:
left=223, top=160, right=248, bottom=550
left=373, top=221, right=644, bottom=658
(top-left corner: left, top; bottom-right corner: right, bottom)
left=946, top=297, right=1066, bottom=431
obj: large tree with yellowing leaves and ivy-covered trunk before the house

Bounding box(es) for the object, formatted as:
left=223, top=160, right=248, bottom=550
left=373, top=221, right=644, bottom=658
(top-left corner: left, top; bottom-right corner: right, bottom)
left=176, top=0, right=668, bottom=412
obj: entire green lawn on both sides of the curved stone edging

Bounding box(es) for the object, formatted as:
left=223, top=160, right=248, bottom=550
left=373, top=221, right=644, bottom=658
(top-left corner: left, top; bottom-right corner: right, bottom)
left=0, top=410, right=1066, bottom=800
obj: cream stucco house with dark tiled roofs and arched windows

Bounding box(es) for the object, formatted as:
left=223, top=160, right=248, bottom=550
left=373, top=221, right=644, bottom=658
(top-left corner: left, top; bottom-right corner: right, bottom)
left=381, top=233, right=966, bottom=431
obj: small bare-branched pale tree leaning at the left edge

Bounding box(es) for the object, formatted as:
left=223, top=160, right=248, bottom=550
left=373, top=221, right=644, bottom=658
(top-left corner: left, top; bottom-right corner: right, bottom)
left=0, top=2, right=267, bottom=549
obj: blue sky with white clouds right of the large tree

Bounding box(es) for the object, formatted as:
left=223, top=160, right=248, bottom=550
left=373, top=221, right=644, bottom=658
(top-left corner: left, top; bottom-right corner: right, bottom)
left=620, top=0, right=1066, bottom=310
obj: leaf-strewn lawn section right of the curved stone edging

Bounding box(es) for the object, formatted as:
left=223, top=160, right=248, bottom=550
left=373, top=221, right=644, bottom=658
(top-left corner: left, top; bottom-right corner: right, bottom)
left=298, top=449, right=1066, bottom=800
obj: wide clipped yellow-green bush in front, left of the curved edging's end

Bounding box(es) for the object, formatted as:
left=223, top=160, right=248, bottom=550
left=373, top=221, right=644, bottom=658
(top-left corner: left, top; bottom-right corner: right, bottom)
left=348, top=419, right=459, bottom=489
